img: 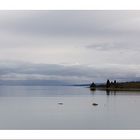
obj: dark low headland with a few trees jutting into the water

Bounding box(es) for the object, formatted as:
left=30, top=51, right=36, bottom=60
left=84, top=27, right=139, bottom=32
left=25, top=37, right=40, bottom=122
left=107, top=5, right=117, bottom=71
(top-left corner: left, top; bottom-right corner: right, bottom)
left=90, top=80, right=140, bottom=91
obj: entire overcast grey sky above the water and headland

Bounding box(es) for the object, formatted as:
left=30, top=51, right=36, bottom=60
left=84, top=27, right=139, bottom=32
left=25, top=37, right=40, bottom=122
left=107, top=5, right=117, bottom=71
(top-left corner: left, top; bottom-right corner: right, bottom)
left=0, top=11, right=140, bottom=83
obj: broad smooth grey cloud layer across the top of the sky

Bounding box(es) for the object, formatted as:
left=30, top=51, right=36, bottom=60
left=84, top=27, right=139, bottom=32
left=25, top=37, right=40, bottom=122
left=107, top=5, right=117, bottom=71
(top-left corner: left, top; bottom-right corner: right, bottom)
left=0, top=11, right=140, bottom=37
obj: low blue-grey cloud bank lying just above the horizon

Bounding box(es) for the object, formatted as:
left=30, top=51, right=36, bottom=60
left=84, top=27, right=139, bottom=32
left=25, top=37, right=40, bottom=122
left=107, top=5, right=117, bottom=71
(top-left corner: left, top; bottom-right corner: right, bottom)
left=0, top=63, right=140, bottom=84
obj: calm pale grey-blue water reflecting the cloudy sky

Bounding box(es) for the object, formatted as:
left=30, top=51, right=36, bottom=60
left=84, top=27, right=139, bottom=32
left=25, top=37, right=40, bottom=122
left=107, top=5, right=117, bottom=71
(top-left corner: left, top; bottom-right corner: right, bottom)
left=0, top=86, right=140, bottom=129
